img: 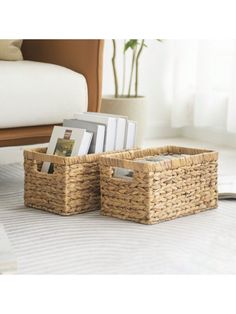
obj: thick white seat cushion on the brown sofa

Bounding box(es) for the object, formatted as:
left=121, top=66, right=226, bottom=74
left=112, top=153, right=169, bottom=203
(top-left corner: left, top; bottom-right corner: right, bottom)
left=0, top=61, right=88, bottom=128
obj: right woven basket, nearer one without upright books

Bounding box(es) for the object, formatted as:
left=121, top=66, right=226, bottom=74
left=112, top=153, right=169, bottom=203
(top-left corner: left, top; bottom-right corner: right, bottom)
left=100, top=146, right=218, bottom=224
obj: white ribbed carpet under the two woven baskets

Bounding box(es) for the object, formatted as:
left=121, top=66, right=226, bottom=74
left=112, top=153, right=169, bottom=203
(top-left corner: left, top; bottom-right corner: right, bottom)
left=0, top=164, right=236, bottom=274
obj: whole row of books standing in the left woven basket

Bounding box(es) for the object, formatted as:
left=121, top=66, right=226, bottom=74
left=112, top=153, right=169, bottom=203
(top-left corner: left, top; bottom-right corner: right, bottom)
left=42, top=112, right=137, bottom=172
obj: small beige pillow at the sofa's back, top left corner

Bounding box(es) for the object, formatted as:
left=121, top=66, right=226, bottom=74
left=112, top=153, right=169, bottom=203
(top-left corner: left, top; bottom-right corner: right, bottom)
left=0, top=39, right=23, bottom=61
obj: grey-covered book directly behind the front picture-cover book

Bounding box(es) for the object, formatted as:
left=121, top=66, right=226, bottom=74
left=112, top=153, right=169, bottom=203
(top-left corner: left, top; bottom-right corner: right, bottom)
left=63, top=119, right=106, bottom=154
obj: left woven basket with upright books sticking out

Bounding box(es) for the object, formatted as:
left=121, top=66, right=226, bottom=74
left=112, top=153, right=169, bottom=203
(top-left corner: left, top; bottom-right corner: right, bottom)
left=24, top=148, right=128, bottom=215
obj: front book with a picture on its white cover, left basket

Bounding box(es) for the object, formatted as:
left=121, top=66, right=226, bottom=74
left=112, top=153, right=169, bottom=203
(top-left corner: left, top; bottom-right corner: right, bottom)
left=41, top=126, right=93, bottom=172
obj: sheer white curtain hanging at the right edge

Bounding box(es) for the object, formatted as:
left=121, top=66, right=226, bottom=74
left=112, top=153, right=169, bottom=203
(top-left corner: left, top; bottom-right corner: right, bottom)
left=171, top=40, right=236, bottom=133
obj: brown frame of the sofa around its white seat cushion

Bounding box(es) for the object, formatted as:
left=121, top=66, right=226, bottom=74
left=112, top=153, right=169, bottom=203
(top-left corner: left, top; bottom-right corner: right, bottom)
left=0, top=40, right=104, bottom=147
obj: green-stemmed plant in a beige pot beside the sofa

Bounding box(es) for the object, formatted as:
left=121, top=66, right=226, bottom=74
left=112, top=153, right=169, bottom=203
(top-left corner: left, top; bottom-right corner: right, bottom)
left=101, top=39, right=160, bottom=146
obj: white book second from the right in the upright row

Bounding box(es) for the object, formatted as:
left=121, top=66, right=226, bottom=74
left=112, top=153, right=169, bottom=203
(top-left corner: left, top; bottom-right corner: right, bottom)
left=85, top=112, right=128, bottom=150
